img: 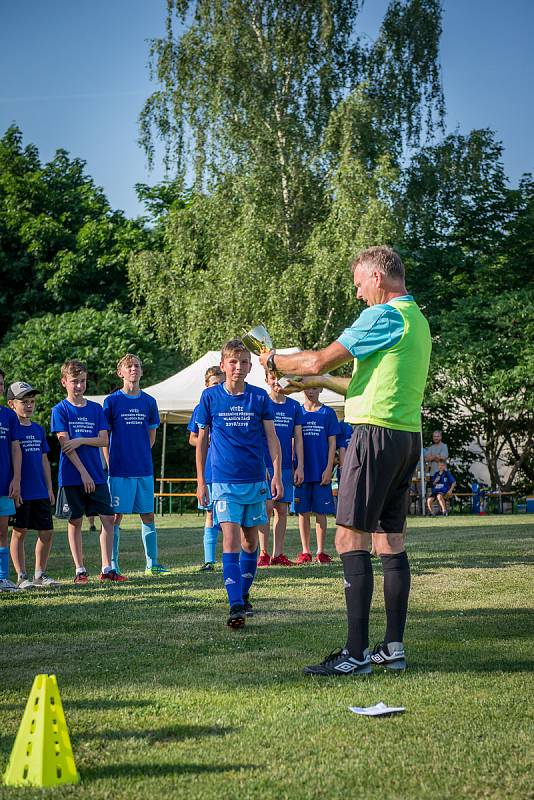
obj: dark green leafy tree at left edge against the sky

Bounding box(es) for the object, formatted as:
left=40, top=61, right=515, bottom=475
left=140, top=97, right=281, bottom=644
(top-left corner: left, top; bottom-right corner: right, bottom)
left=0, top=126, right=151, bottom=337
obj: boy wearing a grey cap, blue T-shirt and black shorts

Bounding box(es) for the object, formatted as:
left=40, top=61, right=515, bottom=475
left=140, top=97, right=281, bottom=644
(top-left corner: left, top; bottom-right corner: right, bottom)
left=7, top=381, right=59, bottom=589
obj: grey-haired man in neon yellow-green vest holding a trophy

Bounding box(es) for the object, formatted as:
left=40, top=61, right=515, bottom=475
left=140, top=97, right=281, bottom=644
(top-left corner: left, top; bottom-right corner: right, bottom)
left=260, top=247, right=431, bottom=675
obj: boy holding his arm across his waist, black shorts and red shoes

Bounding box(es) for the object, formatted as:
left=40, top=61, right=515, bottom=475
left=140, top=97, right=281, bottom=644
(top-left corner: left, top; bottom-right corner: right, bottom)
left=50, top=359, right=122, bottom=585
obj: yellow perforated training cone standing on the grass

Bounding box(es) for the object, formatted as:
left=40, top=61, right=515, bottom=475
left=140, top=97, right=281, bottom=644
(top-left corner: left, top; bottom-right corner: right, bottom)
left=4, top=675, right=80, bottom=786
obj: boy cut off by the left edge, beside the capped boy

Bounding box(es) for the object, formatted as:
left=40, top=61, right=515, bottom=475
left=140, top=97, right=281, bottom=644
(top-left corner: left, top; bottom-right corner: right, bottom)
left=0, top=370, right=22, bottom=592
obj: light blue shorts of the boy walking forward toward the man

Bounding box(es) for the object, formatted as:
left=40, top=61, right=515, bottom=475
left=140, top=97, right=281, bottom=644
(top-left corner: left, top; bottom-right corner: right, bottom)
left=212, top=481, right=268, bottom=528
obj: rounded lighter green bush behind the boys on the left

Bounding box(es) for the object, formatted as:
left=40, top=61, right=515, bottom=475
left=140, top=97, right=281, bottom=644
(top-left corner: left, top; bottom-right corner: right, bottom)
left=0, top=304, right=181, bottom=429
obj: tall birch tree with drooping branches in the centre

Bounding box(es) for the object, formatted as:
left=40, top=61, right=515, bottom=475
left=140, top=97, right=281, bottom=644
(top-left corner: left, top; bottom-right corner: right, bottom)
left=130, top=0, right=442, bottom=355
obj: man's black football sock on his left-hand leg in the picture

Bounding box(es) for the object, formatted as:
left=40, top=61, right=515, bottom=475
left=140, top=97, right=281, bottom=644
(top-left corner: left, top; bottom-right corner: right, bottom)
left=341, top=550, right=373, bottom=661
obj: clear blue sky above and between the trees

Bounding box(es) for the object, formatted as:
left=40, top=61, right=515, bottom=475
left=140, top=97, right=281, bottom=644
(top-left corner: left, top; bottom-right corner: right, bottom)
left=0, top=0, right=534, bottom=216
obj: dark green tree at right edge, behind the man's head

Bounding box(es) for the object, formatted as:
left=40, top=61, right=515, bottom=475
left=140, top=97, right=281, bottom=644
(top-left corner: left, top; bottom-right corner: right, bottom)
left=400, top=130, right=534, bottom=318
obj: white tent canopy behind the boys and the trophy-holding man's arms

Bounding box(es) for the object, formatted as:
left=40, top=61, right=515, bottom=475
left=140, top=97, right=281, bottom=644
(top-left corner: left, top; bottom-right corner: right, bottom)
left=88, top=347, right=345, bottom=425
